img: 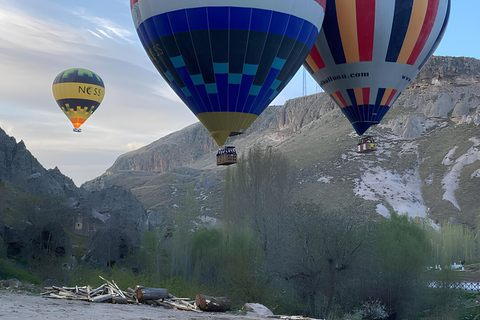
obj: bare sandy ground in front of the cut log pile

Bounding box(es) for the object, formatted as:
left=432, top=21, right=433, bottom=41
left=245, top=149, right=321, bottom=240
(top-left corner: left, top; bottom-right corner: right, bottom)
left=0, top=289, right=284, bottom=320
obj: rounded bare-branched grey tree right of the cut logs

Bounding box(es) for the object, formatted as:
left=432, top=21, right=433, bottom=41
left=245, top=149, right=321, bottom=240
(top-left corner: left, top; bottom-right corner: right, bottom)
left=277, top=202, right=371, bottom=318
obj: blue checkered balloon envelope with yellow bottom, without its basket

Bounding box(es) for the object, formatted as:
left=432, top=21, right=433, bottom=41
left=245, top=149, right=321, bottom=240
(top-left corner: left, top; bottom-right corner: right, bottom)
left=130, top=0, right=325, bottom=164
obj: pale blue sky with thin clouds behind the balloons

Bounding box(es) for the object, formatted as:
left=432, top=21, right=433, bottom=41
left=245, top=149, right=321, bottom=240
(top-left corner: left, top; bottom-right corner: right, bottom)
left=0, top=0, right=480, bottom=186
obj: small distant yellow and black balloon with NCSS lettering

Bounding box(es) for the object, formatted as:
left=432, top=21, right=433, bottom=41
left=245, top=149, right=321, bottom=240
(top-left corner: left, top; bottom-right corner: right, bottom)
left=52, top=68, right=105, bottom=132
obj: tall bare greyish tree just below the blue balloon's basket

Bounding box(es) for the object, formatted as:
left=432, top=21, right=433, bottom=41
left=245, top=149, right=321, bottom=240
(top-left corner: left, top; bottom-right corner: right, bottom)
left=223, top=145, right=293, bottom=259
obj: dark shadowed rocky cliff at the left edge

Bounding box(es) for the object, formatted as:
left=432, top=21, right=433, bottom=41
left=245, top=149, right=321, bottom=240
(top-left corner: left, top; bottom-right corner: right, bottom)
left=0, top=129, right=147, bottom=266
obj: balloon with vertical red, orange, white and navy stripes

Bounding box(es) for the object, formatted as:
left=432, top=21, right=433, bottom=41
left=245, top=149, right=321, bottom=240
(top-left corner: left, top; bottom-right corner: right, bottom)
left=304, top=0, right=450, bottom=146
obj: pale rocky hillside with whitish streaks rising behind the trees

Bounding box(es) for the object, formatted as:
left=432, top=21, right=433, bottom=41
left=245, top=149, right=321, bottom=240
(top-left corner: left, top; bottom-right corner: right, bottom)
left=83, top=57, right=480, bottom=226
